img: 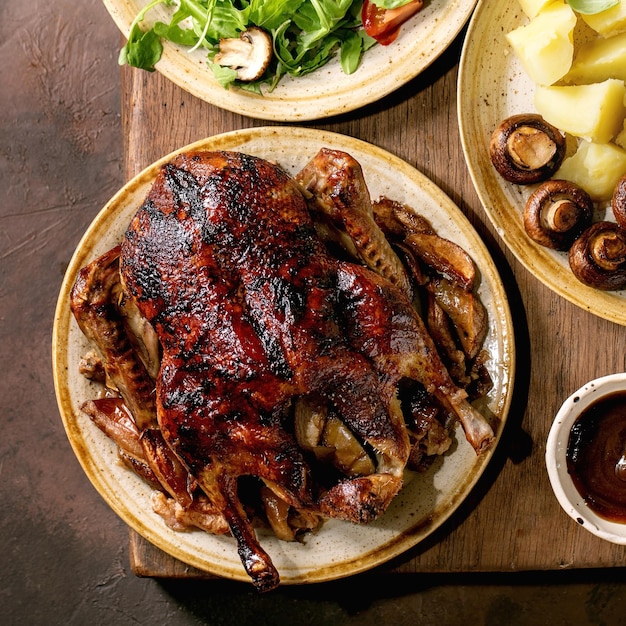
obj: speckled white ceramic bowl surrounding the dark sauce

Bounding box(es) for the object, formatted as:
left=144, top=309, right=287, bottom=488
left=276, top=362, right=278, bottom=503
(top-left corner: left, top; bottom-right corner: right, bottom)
left=546, top=373, right=626, bottom=545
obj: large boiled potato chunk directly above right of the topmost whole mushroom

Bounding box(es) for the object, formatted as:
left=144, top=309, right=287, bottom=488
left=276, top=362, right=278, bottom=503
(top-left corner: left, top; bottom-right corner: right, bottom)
left=535, top=78, right=626, bottom=143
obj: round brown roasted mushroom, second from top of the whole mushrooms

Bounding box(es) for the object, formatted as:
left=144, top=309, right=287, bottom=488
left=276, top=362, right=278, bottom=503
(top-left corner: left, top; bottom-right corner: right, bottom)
left=524, top=180, right=593, bottom=250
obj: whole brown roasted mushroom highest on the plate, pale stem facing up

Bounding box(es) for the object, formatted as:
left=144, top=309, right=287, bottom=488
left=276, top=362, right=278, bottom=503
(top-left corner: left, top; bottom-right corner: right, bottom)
left=489, top=113, right=565, bottom=185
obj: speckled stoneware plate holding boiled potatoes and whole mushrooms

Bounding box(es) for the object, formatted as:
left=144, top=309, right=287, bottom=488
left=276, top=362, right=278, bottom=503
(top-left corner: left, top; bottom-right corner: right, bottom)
left=457, top=0, right=626, bottom=325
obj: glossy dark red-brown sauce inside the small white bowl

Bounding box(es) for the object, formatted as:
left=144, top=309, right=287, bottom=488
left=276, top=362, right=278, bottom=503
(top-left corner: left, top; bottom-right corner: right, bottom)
left=567, top=391, right=626, bottom=523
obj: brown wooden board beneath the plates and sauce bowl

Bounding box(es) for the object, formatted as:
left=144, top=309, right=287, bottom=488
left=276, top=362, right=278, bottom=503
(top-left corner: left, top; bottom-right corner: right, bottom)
left=121, top=40, right=626, bottom=577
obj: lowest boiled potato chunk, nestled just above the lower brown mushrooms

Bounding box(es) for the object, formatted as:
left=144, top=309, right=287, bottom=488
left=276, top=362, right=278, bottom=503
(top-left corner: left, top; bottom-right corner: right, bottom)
left=553, top=141, right=626, bottom=202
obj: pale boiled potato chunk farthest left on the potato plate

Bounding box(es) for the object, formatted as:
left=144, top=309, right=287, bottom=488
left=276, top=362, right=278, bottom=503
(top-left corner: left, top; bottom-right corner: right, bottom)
left=506, top=2, right=576, bottom=85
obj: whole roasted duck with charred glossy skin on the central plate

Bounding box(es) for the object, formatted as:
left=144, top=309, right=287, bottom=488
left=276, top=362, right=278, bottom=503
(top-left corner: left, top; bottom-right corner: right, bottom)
left=72, top=150, right=494, bottom=591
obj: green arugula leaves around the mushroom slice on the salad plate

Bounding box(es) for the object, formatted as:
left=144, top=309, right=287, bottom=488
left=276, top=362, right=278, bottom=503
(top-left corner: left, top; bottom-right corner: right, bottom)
left=120, top=0, right=386, bottom=93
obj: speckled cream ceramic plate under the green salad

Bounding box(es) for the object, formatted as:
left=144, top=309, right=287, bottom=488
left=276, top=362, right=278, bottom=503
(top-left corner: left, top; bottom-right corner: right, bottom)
left=104, top=0, right=476, bottom=122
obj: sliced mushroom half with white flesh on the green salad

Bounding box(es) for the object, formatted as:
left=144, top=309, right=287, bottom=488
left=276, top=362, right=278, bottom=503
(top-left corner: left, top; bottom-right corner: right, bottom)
left=213, top=26, right=272, bottom=82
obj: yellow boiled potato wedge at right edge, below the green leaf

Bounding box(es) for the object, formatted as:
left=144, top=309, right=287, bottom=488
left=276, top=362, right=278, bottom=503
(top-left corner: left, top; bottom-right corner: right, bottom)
left=564, top=32, right=626, bottom=83
